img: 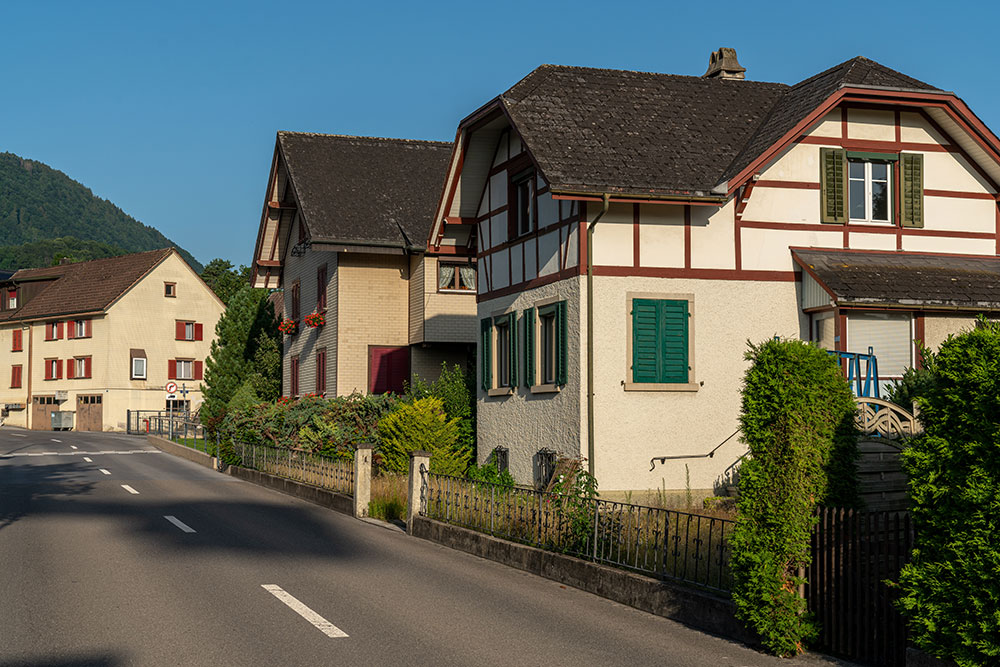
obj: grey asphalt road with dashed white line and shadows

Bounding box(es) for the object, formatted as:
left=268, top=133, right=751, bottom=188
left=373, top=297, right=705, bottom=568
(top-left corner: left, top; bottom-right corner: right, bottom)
left=0, top=427, right=852, bottom=667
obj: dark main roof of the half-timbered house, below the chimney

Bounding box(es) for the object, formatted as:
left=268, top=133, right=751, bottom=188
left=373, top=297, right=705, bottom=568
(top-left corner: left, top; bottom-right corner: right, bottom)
left=500, top=57, right=931, bottom=195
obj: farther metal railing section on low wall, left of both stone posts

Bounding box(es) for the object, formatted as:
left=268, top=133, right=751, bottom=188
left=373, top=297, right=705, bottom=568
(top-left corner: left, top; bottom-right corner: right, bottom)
left=231, top=442, right=354, bottom=496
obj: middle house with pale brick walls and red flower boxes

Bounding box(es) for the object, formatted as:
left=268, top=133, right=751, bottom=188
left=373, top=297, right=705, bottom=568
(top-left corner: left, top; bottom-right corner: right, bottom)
left=253, top=132, right=476, bottom=396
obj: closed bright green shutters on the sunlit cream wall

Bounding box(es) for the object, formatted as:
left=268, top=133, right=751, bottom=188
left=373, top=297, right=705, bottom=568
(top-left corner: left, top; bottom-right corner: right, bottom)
left=632, top=299, right=690, bottom=384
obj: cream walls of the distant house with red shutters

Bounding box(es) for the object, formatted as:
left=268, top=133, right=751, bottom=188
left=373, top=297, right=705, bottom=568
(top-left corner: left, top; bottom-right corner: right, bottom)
left=0, top=253, right=225, bottom=430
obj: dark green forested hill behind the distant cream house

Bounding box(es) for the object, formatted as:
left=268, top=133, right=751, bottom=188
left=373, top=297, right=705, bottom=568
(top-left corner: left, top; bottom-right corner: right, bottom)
left=0, top=153, right=202, bottom=273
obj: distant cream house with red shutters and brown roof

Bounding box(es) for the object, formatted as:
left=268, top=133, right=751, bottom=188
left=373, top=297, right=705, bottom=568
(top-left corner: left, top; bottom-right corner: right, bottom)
left=0, top=248, right=225, bottom=431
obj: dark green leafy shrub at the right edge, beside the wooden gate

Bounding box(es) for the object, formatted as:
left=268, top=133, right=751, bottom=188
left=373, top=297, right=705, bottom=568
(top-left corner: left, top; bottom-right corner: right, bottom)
left=899, top=321, right=1000, bottom=665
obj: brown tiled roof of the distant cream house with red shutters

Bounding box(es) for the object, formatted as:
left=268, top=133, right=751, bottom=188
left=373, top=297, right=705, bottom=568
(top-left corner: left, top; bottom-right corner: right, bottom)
left=0, top=248, right=176, bottom=320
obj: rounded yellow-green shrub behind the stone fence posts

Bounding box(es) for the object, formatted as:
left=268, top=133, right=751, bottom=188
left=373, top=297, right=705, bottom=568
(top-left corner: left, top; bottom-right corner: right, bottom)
left=378, top=398, right=471, bottom=475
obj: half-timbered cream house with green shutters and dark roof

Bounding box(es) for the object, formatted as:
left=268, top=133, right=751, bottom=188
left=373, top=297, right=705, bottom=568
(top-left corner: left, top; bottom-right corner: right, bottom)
left=430, top=49, right=1000, bottom=494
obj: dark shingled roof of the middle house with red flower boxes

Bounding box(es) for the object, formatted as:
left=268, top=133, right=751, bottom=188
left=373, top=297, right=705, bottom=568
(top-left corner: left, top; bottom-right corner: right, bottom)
left=278, top=132, right=451, bottom=246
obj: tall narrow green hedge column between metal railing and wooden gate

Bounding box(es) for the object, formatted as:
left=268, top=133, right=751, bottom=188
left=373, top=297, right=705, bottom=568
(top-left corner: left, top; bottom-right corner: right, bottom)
left=730, top=340, right=858, bottom=655
